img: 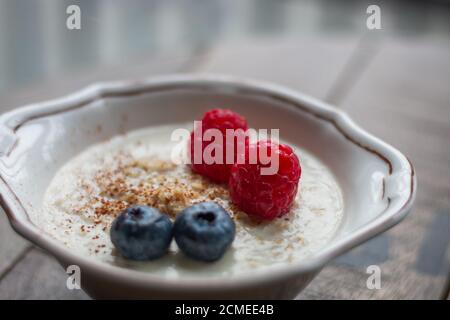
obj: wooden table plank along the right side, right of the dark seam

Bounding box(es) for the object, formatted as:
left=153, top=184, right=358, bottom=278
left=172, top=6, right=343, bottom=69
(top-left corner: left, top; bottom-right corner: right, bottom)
left=299, top=39, right=450, bottom=299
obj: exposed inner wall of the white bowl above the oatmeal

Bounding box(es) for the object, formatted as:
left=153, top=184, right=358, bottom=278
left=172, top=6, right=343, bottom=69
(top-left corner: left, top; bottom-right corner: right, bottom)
left=0, top=87, right=390, bottom=251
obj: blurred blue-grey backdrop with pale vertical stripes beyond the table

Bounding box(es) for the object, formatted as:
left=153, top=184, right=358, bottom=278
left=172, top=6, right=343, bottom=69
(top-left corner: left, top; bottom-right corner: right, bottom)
left=0, top=0, right=450, bottom=105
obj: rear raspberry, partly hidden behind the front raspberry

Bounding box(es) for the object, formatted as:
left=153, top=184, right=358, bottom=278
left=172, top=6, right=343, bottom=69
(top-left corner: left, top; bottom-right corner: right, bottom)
left=190, top=109, right=248, bottom=183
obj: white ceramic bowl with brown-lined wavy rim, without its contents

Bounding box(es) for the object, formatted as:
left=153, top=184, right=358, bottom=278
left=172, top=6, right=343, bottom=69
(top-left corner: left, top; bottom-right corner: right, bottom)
left=0, top=75, right=416, bottom=299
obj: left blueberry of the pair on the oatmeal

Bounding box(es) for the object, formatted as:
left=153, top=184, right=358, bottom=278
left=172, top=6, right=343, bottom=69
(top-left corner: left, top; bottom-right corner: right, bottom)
left=110, top=206, right=173, bottom=260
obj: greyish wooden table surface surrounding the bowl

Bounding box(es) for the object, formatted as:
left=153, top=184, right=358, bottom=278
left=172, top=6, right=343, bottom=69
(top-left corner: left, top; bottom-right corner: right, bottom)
left=0, top=33, right=450, bottom=299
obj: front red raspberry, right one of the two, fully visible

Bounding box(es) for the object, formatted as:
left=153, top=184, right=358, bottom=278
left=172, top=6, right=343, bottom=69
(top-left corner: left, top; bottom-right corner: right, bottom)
left=229, top=141, right=301, bottom=220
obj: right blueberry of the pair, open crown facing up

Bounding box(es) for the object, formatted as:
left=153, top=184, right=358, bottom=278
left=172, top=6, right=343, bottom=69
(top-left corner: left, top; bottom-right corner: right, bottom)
left=173, top=202, right=235, bottom=261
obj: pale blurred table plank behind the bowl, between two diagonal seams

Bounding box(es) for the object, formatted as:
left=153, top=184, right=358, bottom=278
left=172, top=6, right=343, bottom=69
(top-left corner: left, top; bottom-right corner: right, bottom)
left=194, top=37, right=359, bottom=99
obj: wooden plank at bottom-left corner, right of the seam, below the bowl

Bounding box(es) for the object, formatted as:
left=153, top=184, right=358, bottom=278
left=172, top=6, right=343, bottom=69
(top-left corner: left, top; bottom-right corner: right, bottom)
left=0, top=249, right=89, bottom=299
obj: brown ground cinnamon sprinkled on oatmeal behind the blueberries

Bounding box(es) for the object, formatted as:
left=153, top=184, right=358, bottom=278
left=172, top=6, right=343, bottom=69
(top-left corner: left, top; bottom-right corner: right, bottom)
left=70, top=153, right=243, bottom=240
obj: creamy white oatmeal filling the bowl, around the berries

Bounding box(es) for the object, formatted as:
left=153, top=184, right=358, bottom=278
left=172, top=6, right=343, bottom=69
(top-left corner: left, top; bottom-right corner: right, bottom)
left=38, top=125, right=343, bottom=277
